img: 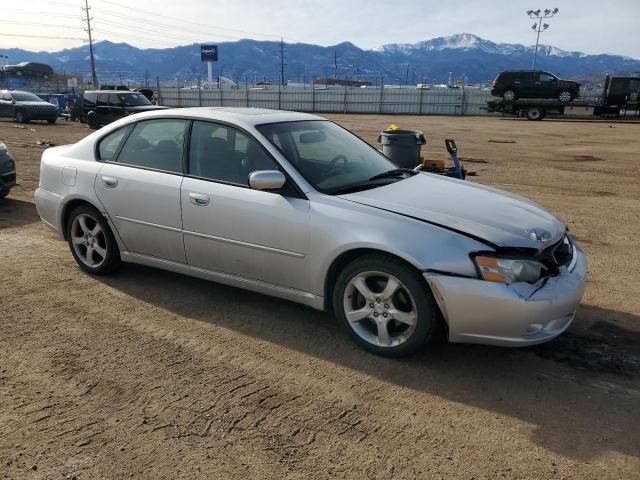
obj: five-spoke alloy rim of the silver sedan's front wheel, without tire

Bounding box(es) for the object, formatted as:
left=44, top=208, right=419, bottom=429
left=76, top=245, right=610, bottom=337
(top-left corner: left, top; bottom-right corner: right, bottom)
left=343, top=271, right=418, bottom=347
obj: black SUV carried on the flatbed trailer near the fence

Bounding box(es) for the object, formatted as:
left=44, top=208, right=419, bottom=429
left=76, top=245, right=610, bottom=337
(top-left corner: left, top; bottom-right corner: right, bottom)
left=491, top=70, right=580, bottom=103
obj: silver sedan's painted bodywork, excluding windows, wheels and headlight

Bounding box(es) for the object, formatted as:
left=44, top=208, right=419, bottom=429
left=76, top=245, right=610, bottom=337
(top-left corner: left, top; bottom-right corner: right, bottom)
left=35, top=108, right=586, bottom=345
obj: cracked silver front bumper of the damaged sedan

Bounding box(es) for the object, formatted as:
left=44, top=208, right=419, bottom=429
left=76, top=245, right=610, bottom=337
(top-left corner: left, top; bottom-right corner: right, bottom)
left=424, top=245, right=587, bottom=347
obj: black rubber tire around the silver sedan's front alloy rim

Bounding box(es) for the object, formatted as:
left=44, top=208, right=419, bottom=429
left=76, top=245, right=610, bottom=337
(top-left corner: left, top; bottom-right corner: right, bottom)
left=332, top=255, right=442, bottom=357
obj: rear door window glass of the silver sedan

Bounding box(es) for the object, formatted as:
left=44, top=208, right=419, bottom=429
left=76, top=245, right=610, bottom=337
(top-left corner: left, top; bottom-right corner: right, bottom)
left=117, top=118, right=188, bottom=173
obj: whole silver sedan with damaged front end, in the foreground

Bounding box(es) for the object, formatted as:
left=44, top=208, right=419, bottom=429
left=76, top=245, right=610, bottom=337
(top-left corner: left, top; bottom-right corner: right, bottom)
left=35, top=108, right=586, bottom=356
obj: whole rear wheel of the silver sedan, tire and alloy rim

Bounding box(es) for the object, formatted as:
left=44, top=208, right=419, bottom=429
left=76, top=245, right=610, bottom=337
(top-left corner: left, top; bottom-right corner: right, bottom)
left=67, top=205, right=120, bottom=275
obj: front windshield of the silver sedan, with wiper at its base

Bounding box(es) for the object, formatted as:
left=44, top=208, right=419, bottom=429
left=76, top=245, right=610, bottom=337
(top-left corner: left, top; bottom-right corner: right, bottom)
left=257, top=120, right=406, bottom=194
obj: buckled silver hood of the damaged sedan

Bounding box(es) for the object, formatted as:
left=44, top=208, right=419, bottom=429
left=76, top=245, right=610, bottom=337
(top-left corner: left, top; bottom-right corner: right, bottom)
left=340, top=173, right=566, bottom=249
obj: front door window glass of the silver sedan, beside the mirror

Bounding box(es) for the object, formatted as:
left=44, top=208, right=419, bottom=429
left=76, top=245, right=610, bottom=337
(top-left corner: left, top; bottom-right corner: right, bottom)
left=189, top=121, right=277, bottom=185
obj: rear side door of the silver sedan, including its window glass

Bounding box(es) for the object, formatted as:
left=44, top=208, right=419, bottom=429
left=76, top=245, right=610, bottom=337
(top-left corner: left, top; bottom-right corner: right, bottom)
left=95, top=119, right=188, bottom=262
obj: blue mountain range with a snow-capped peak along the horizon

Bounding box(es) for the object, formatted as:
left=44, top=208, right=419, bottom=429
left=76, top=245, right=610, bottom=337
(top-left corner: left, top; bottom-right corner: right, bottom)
left=0, top=33, right=640, bottom=84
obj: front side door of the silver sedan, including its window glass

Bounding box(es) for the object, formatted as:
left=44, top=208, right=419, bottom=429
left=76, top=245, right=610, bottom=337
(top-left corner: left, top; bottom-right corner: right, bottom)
left=181, top=121, right=309, bottom=290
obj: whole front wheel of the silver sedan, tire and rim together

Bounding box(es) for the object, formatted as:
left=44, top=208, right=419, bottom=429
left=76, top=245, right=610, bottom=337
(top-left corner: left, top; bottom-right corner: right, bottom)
left=333, top=255, right=440, bottom=357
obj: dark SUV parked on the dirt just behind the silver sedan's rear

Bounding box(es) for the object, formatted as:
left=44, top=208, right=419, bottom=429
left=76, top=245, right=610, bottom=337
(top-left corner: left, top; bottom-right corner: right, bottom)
left=82, top=90, right=167, bottom=129
